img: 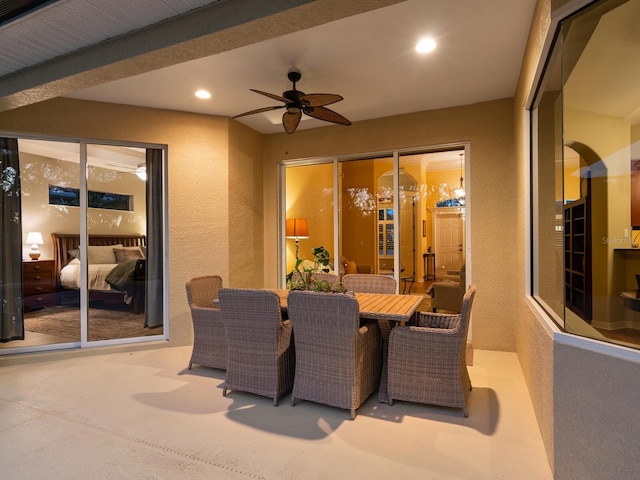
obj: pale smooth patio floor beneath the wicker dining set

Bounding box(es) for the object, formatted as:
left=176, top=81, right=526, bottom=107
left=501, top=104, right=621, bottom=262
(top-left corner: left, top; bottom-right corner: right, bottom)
left=0, top=345, right=552, bottom=480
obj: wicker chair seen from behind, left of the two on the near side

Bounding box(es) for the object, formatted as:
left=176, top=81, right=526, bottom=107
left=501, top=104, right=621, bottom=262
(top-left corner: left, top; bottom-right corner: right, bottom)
left=219, top=288, right=295, bottom=406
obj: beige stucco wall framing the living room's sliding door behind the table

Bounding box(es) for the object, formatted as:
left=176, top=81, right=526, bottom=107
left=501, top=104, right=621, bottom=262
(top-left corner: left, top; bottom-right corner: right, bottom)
left=264, top=99, right=516, bottom=351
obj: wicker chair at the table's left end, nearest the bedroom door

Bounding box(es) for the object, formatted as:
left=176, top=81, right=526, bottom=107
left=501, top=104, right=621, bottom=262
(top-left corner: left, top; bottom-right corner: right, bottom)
left=186, top=275, right=227, bottom=370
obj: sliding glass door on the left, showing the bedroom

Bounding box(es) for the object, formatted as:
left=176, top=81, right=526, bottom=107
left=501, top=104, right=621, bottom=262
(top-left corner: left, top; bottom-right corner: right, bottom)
left=0, top=139, right=166, bottom=354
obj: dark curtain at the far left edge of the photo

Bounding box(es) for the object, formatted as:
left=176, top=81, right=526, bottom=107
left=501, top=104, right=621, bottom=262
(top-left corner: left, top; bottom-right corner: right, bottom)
left=0, top=138, right=24, bottom=342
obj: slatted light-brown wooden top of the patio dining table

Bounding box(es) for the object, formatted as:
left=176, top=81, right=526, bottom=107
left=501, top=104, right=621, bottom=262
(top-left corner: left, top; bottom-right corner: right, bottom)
left=273, top=290, right=424, bottom=322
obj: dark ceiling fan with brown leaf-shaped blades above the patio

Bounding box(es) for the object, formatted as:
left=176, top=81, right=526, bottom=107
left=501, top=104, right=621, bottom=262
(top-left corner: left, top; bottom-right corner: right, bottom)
left=233, top=69, right=351, bottom=133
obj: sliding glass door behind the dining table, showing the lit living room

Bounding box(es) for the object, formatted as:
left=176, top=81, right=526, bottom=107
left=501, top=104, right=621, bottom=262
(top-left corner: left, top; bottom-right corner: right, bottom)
left=282, top=148, right=468, bottom=293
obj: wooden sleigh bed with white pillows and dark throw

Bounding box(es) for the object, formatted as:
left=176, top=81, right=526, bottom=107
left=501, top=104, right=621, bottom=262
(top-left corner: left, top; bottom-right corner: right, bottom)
left=51, top=233, right=146, bottom=313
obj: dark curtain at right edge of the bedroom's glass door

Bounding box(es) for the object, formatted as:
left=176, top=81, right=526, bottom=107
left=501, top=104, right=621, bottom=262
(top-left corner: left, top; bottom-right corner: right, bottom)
left=145, top=148, right=164, bottom=328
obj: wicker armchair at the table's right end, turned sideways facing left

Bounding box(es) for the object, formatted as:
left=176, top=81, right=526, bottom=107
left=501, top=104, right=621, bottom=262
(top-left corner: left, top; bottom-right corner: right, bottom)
left=388, top=285, right=476, bottom=417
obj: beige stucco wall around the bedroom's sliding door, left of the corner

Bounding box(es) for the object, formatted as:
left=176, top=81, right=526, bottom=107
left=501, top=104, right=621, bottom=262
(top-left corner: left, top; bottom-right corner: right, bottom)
left=0, top=98, right=235, bottom=344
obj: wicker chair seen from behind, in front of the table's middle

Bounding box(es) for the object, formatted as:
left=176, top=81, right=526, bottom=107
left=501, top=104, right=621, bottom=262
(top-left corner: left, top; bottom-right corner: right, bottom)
left=287, top=290, right=382, bottom=419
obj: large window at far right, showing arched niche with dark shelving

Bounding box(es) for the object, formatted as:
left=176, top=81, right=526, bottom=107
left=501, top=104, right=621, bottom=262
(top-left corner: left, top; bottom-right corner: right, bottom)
left=532, top=0, right=640, bottom=348
